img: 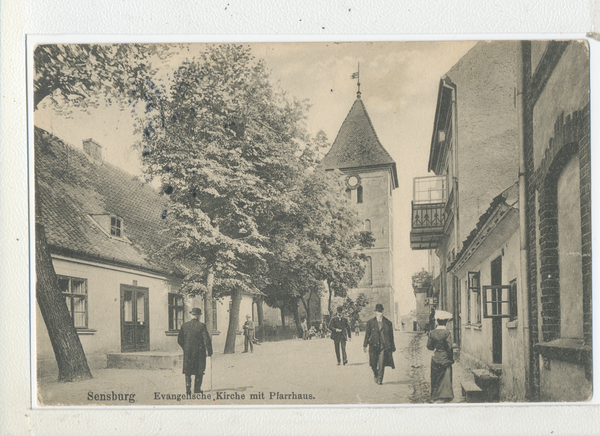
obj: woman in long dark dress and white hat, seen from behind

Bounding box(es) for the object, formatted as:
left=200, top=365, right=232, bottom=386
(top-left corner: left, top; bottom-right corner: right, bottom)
left=427, top=319, right=454, bottom=403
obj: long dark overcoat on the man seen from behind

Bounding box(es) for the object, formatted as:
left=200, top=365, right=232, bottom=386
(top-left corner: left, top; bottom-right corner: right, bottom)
left=177, top=319, right=212, bottom=375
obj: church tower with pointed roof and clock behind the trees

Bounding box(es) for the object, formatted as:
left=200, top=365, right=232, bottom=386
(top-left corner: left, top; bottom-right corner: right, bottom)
left=321, top=88, right=398, bottom=326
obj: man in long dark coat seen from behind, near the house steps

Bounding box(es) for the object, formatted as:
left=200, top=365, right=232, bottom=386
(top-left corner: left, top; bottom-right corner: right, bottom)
left=177, top=307, right=212, bottom=395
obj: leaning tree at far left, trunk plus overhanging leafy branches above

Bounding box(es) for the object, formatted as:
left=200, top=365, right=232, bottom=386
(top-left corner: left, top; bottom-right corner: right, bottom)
left=33, top=44, right=166, bottom=381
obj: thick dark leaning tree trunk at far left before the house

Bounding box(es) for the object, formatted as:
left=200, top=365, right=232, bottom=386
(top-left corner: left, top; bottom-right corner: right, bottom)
left=35, top=223, right=92, bottom=382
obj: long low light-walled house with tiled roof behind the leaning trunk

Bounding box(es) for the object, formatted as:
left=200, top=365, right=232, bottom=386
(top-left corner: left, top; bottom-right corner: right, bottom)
left=35, top=128, right=256, bottom=375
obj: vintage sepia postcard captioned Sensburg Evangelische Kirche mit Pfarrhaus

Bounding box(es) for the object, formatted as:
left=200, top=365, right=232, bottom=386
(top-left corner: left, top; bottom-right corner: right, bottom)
left=30, top=40, right=593, bottom=407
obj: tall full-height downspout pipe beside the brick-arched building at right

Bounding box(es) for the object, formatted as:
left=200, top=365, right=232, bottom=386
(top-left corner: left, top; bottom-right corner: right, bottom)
left=515, top=42, right=531, bottom=399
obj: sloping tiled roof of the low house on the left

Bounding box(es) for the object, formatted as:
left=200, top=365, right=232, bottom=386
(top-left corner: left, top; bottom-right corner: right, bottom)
left=35, top=127, right=174, bottom=273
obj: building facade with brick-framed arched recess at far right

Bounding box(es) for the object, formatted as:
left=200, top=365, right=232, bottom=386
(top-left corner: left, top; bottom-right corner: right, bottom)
left=522, top=41, right=593, bottom=401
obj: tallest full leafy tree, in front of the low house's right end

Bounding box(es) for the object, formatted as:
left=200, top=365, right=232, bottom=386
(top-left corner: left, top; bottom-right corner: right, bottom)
left=139, top=44, right=304, bottom=353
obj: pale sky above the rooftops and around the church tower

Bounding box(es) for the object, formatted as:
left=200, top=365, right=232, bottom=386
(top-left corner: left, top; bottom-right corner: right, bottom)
left=34, top=41, right=475, bottom=314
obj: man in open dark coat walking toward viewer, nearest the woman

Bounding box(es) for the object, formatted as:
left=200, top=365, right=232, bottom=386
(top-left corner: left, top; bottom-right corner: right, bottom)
left=363, top=304, right=396, bottom=385
